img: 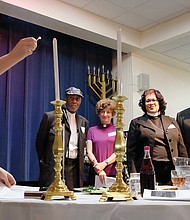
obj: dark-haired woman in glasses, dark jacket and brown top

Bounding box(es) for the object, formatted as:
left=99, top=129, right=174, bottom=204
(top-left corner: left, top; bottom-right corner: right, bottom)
left=127, top=89, right=187, bottom=185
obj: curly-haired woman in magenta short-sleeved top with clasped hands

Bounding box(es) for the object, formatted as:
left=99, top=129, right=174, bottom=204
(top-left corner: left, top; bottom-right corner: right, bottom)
left=87, top=99, right=116, bottom=184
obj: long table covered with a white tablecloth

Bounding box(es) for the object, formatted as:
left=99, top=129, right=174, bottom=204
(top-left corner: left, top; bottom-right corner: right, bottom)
left=0, top=193, right=190, bottom=220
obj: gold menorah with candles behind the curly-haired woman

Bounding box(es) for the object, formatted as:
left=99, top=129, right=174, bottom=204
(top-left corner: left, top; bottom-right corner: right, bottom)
left=88, top=66, right=117, bottom=99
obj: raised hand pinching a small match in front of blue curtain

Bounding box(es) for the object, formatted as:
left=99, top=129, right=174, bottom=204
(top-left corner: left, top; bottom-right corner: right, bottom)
left=10, top=37, right=41, bottom=60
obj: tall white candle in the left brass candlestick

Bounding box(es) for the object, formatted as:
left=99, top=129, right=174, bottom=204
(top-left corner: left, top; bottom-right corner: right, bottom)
left=53, top=38, right=60, bottom=100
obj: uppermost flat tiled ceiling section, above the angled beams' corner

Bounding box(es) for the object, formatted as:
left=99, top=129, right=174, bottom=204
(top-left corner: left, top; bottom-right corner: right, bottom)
left=61, top=0, right=190, bottom=31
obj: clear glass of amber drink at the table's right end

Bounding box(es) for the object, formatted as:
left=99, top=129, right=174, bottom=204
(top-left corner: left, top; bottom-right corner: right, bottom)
left=171, top=170, right=186, bottom=187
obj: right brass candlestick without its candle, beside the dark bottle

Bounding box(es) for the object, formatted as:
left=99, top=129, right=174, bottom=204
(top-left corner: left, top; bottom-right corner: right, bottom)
left=100, top=95, right=132, bottom=202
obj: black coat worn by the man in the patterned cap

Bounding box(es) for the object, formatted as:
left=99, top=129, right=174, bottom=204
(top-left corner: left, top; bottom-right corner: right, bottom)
left=36, top=107, right=88, bottom=187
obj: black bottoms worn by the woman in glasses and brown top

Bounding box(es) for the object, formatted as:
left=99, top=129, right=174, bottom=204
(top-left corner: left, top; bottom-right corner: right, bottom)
left=153, top=160, right=175, bottom=185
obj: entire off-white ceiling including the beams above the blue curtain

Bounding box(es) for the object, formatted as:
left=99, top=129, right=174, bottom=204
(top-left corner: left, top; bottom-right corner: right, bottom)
left=0, top=0, right=190, bottom=71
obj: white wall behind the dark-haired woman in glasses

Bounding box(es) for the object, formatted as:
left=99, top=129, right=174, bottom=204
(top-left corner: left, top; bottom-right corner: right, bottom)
left=113, top=54, right=190, bottom=130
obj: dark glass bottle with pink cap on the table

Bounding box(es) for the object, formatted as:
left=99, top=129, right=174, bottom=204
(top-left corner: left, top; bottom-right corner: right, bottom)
left=140, top=146, right=155, bottom=197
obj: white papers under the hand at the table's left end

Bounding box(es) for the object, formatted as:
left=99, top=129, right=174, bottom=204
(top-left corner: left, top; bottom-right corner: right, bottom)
left=0, top=183, right=39, bottom=199
